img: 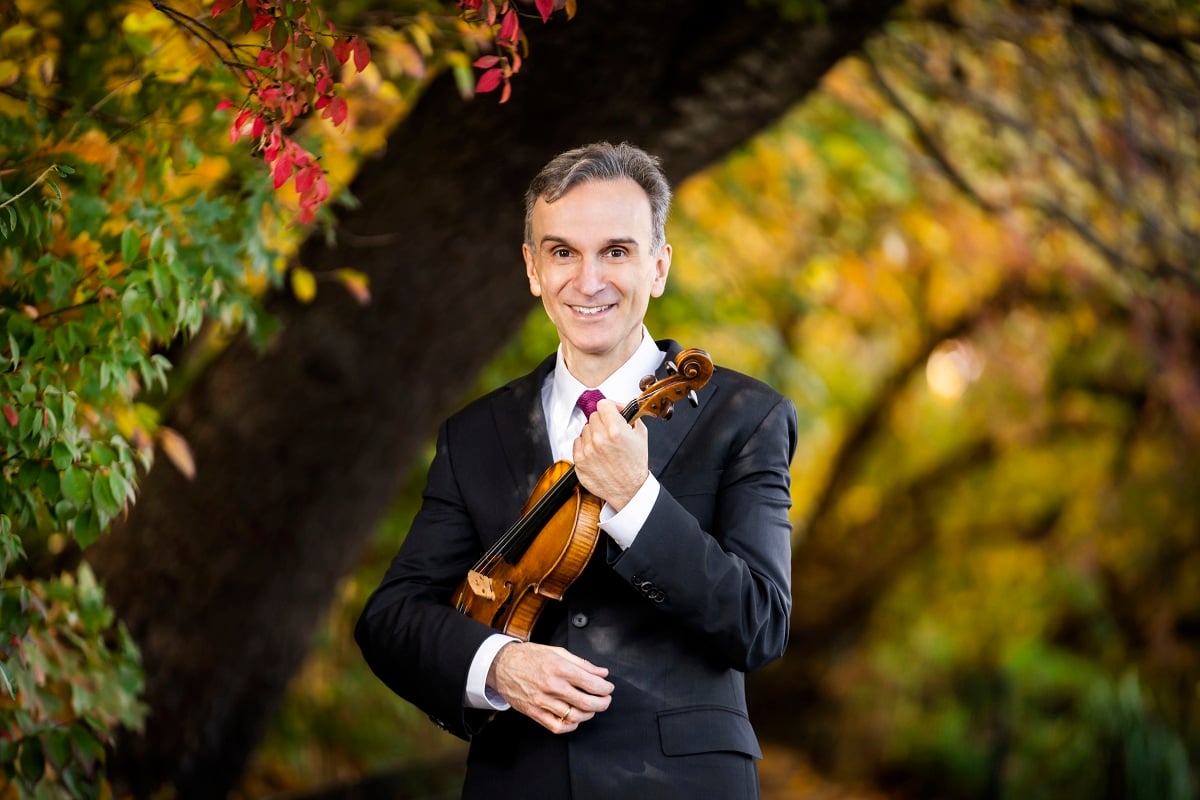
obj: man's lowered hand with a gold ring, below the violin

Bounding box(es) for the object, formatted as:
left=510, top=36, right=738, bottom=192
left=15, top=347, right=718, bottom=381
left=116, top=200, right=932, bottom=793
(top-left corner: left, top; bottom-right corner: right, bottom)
left=487, top=642, right=613, bottom=733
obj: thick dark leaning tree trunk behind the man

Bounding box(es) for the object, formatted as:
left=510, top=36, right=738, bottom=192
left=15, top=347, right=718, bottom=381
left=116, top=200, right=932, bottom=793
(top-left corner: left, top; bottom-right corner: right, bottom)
left=89, top=0, right=893, bottom=798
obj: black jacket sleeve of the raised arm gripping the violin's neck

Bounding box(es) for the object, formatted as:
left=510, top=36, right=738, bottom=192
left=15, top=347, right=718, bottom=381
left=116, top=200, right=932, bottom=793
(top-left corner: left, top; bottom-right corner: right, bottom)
left=608, top=395, right=797, bottom=672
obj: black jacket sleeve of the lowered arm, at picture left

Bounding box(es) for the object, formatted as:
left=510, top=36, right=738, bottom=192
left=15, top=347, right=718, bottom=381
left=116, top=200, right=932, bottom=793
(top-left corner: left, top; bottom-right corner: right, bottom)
left=354, top=423, right=496, bottom=738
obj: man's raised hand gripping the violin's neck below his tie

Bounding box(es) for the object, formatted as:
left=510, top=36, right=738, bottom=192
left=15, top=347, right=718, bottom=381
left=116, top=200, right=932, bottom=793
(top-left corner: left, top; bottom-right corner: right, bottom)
left=575, top=399, right=649, bottom=511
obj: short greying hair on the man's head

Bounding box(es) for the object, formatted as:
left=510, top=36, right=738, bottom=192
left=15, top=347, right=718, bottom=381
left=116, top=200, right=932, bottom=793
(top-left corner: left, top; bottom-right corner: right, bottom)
left=526, top=142, right=671, bottom=252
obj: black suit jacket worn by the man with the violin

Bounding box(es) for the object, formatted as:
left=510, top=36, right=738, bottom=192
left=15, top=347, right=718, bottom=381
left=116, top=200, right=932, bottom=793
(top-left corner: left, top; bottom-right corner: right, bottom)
left=355, top=342, right=797, bottom=800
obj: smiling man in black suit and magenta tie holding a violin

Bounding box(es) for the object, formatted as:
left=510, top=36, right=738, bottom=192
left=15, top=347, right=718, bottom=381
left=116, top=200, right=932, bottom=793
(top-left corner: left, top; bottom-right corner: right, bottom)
left=355, top=143, right=797, bottom=800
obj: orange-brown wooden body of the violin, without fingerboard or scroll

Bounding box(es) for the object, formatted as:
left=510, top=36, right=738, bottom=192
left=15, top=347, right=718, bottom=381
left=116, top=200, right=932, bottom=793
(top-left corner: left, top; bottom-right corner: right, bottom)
left=450, top=461, right=602, bottom=642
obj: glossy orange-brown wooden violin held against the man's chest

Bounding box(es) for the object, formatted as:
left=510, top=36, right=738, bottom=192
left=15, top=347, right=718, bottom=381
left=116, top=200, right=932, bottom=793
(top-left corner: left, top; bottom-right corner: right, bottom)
left=450, top=348, right=713, bottom=642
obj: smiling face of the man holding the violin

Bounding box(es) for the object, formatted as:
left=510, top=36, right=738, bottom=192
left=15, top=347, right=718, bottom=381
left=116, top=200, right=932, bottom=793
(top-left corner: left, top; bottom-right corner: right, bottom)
left=522, top=178, right=671, bottom=379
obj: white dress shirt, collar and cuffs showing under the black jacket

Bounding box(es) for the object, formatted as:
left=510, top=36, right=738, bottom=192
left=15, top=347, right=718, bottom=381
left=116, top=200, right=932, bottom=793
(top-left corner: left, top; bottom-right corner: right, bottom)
left=464, top=326, right=664, bottom=711
